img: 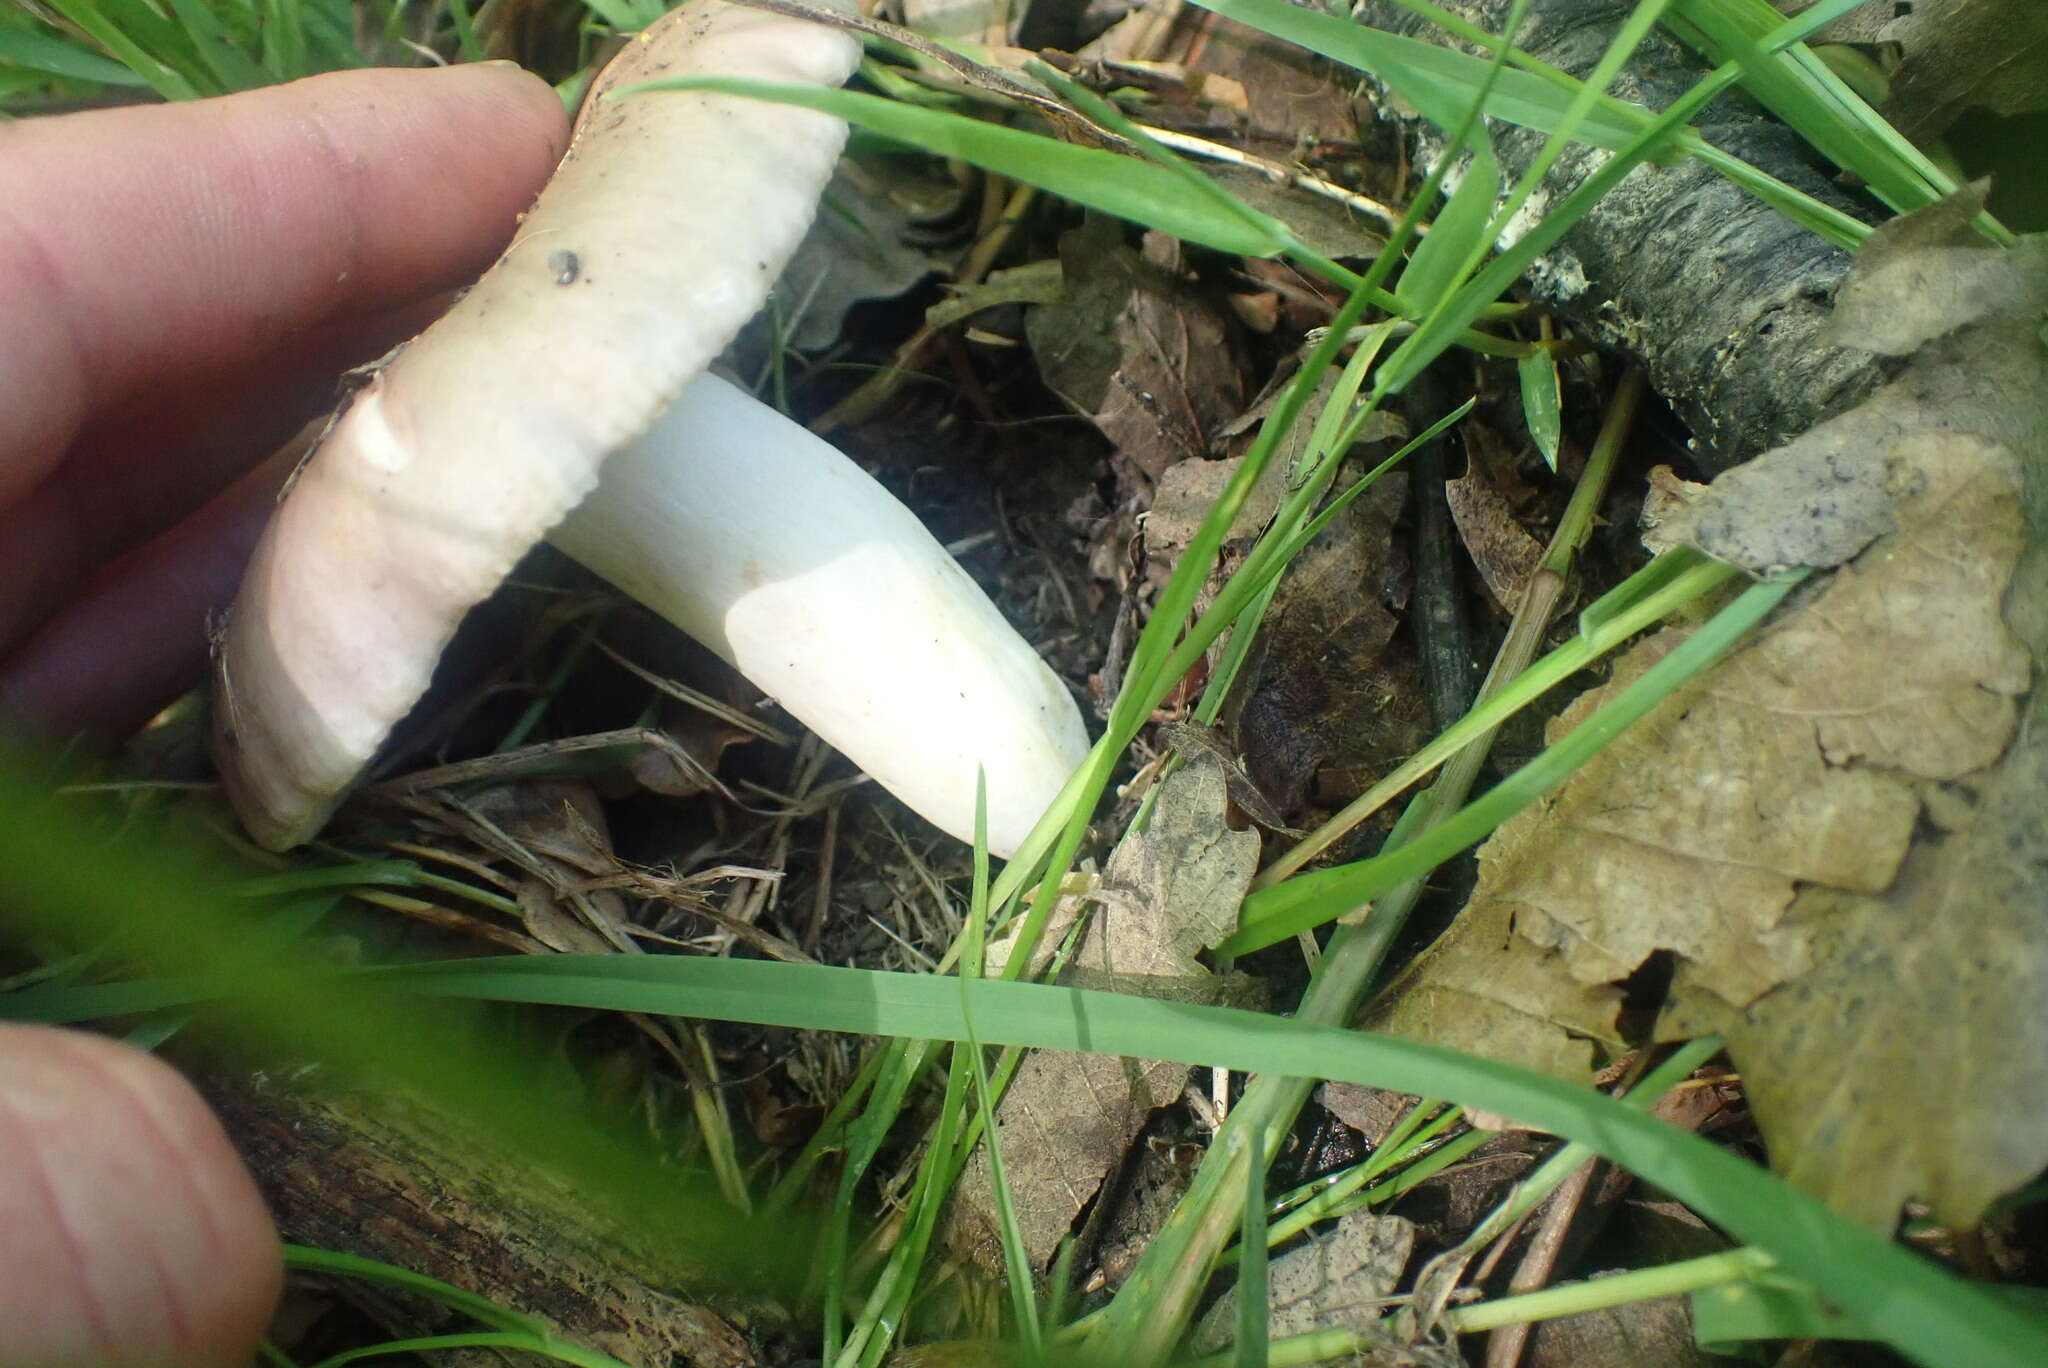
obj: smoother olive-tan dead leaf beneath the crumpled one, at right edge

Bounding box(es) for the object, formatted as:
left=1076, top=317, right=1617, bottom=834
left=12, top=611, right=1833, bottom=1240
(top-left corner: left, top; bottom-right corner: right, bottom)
left=1667, top=216, right=2048, bottom=1227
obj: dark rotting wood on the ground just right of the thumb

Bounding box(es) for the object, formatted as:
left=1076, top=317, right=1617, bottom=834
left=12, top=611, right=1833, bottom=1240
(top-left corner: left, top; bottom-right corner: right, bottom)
left=201, top=1075, right=756, bottom=1368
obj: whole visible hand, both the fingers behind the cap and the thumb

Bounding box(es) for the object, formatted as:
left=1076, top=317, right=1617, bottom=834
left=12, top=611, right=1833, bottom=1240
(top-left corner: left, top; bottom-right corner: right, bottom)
left=0, top=63, right=567, bottom=1368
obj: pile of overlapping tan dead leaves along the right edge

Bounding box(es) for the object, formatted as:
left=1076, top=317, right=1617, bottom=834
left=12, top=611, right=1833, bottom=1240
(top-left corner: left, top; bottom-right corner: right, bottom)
left=1370, top=189, right=2048, bottom=1229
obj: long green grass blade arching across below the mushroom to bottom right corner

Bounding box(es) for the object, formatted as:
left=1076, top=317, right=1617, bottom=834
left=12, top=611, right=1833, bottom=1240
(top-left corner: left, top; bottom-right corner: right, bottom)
left=99, top=954, right=2048, bottom=1368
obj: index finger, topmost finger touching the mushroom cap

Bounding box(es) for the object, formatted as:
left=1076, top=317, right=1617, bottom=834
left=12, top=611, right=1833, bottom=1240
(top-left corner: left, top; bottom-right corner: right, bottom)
left=0, top=63, right=567, bottom=506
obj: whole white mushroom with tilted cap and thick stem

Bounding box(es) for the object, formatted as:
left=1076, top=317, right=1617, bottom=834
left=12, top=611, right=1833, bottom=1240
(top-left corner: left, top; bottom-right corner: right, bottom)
left=213, top=0, right=1087, bottom=854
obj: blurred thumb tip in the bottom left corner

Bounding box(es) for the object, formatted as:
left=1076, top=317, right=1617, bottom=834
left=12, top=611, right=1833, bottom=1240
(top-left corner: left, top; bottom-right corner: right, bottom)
left=0, top=1026, right=283, bottom=1368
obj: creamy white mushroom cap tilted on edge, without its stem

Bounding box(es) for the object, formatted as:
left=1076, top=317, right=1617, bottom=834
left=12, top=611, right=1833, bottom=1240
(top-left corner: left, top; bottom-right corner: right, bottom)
left=215, top=0, right=860, bottom=848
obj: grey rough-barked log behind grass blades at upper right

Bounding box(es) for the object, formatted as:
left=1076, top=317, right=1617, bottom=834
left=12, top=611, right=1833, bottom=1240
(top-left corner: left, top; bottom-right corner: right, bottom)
left=1360, top=0, right=1882, bottom=473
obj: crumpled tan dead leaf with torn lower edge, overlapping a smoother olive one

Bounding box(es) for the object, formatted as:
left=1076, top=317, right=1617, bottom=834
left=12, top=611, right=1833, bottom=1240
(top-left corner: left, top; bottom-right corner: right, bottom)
left=1382, top=436, right=2028, bottom=1073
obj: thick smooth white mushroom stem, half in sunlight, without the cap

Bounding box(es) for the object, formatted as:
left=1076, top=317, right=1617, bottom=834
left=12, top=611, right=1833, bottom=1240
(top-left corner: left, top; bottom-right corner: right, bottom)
left=549, top=375, right=1087, bottom=856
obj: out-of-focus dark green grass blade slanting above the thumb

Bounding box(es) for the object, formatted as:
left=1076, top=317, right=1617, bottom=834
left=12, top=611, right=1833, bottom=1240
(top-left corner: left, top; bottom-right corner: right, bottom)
left=0, top=806, right=813, bottom=1310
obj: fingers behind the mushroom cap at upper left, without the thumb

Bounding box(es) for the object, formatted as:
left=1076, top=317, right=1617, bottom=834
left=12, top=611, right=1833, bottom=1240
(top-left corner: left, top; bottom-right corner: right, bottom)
left=0, top=63, right=567, bottom=739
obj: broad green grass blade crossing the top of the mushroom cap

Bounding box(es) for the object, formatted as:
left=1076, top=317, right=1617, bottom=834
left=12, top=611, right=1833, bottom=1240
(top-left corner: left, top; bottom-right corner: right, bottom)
left=612, top=76, right=1294, bottom=256
